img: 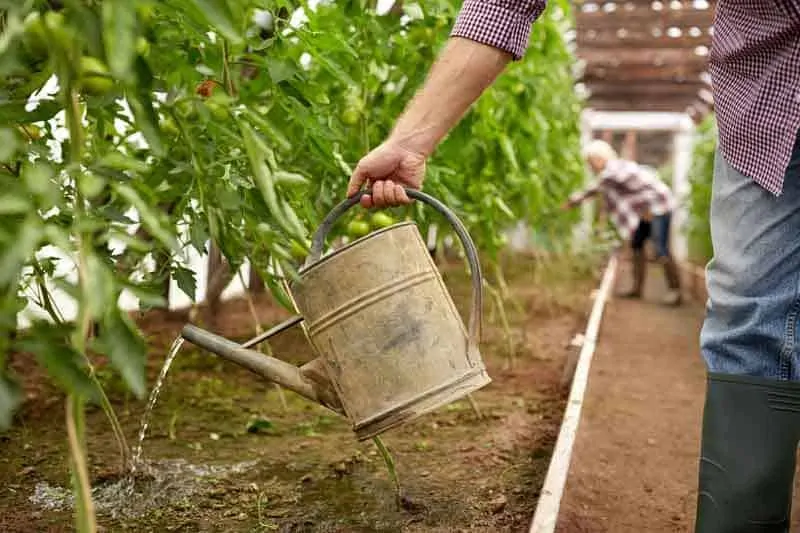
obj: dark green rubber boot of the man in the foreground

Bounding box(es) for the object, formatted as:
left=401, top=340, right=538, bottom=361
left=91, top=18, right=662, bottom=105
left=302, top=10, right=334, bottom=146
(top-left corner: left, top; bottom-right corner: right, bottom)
left=695, top=373, right=800, bottom=533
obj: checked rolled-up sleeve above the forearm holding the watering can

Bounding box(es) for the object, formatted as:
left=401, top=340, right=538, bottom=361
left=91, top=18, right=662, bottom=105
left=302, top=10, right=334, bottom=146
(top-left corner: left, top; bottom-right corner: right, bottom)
left=450, top=0, right=547, bottom=60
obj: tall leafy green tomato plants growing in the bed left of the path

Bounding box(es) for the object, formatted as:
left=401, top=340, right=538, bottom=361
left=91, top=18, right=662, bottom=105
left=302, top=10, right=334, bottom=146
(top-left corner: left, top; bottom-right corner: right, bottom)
left=0, top=0, right=583, bottom=430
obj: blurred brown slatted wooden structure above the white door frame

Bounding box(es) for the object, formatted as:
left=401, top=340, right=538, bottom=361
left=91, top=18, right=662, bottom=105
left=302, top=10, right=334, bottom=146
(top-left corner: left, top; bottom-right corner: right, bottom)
left=573, top=0, right=716, bottom=119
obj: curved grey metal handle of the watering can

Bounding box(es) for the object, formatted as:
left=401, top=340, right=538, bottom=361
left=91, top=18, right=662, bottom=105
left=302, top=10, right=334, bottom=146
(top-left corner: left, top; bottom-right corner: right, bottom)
left=304, top=187, right=483, bottom=352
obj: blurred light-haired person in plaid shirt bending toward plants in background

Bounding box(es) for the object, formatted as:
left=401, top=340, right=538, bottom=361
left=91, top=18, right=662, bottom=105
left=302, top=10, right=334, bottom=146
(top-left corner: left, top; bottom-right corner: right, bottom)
left=562, top=140, right=681, bottom=305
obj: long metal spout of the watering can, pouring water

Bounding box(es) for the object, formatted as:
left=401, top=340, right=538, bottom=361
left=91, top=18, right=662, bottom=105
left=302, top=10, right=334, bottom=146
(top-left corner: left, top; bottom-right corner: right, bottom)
left=181, top=324, right=343, bottom=414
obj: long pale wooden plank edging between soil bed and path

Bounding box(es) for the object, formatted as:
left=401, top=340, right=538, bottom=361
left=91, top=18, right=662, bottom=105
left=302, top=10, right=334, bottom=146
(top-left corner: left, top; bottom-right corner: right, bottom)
left=529, top=254, right=618, bottom=533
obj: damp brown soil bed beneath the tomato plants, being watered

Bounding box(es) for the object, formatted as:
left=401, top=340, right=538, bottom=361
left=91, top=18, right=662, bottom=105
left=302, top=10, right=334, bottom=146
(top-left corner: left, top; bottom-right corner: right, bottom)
left=0, top=254, right=600, bottom=533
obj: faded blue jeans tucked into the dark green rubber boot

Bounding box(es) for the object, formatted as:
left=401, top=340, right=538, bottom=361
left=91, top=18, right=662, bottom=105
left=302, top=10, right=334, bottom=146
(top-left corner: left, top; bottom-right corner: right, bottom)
left=700, top=130, right=800, bottom=381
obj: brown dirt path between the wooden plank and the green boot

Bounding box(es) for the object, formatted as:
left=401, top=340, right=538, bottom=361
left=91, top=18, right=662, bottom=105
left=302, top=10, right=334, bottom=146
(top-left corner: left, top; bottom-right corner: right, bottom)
left=556, top=263, right=705, bottom=533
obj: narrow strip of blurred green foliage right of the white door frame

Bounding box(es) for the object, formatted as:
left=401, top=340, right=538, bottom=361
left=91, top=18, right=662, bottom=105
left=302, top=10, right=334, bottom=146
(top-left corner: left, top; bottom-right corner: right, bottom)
left=689, top=115, right=717, bottom=264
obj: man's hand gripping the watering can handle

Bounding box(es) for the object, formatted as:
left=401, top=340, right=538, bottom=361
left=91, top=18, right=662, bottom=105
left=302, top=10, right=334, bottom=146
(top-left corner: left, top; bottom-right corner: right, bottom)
left=347, top=140, right=426, bottom=208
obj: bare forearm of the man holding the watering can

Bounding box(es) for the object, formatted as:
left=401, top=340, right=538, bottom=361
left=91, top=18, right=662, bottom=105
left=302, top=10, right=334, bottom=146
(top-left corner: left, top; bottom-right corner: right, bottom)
left=390, top=37, right=512, bottom=155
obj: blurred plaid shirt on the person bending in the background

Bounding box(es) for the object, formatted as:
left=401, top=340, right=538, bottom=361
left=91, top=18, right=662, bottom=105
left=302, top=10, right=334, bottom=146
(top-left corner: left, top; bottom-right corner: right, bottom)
left=570, top=159, right=675, bottom=239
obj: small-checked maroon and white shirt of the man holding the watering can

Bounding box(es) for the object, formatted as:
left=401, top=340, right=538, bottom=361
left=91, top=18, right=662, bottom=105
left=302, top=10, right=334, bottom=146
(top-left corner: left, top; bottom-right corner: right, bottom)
left=452, top=0, right=800, bottom=195
